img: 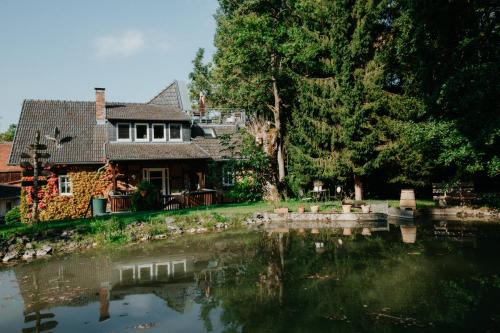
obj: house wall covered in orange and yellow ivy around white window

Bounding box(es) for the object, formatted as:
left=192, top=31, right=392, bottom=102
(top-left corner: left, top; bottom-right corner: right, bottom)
left=21, top=166, right=112, bottom=222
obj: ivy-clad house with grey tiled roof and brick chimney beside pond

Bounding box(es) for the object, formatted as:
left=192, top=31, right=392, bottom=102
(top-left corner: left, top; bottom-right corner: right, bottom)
left=9, top=81, right=245, bottom=220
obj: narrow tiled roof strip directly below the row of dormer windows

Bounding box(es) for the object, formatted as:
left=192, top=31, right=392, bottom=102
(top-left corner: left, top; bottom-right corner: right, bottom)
left=106, top=142, right=212, bottom=161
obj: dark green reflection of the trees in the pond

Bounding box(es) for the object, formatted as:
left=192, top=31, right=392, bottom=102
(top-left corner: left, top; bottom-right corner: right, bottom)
left=196, top=233, right=500, bottom=332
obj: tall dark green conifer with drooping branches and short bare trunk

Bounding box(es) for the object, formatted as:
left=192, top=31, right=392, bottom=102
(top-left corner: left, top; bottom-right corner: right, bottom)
left=290, top=0, right=421, bottom=200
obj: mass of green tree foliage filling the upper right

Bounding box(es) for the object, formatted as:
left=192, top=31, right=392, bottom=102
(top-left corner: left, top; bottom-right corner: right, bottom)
left=204, top=0, right=500, bottom=197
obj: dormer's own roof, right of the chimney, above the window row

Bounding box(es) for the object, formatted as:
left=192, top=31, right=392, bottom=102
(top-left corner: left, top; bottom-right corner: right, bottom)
left=106, top=103, right=189, bottom=121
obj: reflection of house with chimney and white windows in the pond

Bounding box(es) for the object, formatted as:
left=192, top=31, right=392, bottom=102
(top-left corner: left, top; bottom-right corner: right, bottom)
left=15, top=253, right=223, bottom=320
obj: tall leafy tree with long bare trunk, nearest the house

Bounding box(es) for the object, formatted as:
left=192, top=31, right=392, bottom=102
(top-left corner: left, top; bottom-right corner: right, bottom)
left=214, top=0, right=293, bottom=190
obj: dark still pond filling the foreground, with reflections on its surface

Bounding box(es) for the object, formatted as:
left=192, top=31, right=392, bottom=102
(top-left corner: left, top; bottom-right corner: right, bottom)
left=0, top=221, right=500, bottom=333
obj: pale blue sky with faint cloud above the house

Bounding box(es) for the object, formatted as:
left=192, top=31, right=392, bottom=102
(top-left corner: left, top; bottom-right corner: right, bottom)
left=0, top=0, right=217, bottom=131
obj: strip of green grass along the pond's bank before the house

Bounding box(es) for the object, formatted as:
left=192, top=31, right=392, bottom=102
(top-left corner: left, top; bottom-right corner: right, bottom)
left=0, top=199, right=434, bottom=242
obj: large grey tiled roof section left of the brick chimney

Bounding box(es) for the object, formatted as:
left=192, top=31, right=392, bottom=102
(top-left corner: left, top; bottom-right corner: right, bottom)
left=9, top=100, right=107, bottom=164
